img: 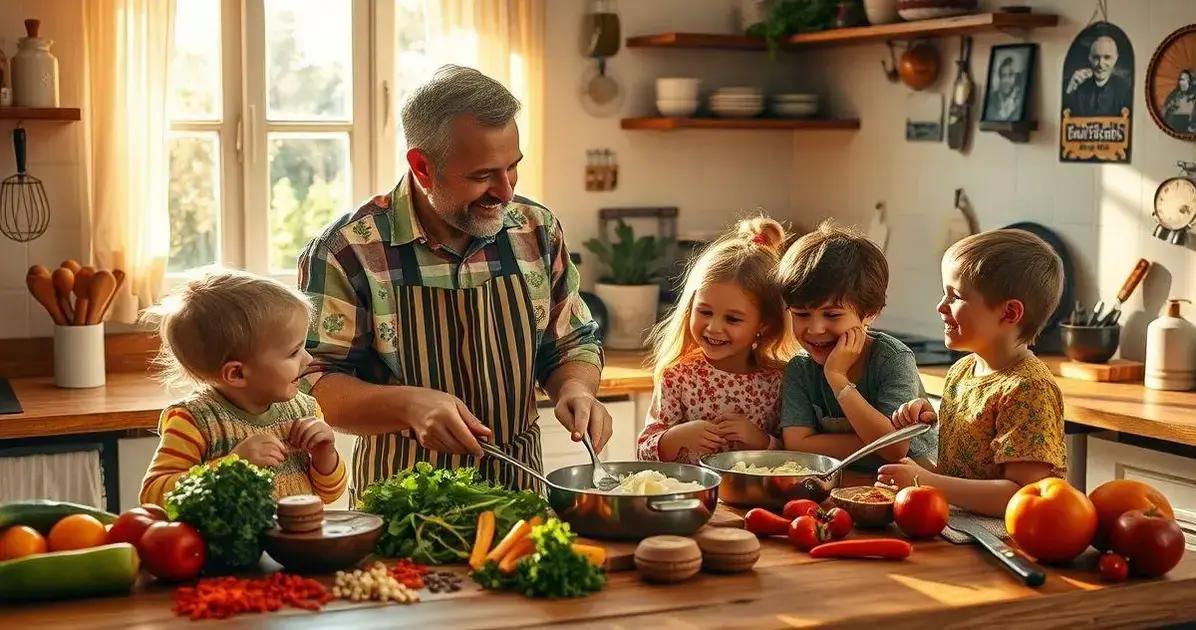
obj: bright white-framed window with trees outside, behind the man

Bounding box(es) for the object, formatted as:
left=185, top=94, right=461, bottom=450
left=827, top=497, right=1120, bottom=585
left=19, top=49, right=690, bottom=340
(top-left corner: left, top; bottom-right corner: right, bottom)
left=169, top=0, right=374, bottom=275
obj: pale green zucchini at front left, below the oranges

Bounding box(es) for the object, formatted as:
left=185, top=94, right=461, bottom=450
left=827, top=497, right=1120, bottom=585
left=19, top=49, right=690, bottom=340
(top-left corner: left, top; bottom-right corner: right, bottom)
left=0, top=543, right=141, bottom=601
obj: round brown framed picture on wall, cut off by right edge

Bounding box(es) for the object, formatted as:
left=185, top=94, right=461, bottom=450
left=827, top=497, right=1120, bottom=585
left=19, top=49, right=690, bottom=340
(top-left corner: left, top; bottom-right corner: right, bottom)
left=1146, top=24, right=1196, bottom=140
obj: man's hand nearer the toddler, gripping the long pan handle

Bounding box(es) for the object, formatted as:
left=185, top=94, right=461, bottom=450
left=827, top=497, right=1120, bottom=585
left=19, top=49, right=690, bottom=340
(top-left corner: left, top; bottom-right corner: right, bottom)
left=408, top=390, right=494, bottom=457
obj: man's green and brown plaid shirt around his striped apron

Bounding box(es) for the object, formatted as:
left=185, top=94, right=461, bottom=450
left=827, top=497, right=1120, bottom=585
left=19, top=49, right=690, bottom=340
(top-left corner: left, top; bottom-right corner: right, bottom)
left=299, top=173, right=603, bottom=392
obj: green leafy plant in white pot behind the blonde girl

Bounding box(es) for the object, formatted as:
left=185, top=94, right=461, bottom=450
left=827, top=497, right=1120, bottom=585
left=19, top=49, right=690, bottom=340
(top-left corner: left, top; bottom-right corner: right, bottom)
left=585, top=220, right=672, bottom=350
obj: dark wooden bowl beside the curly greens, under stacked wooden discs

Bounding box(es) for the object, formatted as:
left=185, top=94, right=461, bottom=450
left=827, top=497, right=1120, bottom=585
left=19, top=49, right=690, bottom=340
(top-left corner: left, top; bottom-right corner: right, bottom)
left=263, top=509, right=385, bottom=573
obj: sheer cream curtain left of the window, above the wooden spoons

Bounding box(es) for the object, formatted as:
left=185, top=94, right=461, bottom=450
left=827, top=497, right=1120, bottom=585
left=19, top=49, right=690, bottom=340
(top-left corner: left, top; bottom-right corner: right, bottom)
left=83, top=0, right=175, bottom=323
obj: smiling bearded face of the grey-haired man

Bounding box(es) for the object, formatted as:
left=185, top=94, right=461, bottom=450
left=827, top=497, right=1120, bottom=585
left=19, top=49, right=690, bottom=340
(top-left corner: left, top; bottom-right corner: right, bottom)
left=427, top=115, right=523, bottom=238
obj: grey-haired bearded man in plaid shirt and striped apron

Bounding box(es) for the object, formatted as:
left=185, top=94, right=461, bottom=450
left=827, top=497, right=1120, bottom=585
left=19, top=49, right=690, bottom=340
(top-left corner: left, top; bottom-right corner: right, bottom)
left=299, top=66, right=611, bottom=497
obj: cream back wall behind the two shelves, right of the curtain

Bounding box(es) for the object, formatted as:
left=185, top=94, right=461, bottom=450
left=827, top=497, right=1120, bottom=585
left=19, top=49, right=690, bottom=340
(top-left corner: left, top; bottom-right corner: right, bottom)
left=541, top=0, right=813, bottom=285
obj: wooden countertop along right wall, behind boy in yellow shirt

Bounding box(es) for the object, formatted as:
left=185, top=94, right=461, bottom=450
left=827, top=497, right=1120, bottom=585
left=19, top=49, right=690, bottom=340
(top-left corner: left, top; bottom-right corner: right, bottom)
left=919, top=356, right=1196, bottom=446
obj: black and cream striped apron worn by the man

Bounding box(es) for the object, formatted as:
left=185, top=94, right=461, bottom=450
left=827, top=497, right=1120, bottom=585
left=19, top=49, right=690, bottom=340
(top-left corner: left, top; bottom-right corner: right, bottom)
left=350, top=231, right=543, bottom=503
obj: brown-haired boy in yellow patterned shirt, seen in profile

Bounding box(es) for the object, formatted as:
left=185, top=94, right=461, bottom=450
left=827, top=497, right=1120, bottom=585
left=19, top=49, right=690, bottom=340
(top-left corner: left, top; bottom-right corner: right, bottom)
left=877, top=230, right=1067, bottom=516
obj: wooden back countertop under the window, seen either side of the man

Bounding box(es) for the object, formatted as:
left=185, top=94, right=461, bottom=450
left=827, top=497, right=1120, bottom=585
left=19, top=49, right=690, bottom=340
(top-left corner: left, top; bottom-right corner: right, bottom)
left=0, top=351, right=652, bottom=440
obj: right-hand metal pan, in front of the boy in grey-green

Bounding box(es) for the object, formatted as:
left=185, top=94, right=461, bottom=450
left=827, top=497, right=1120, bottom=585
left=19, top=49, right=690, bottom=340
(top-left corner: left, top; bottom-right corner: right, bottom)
left=702, top=451, right=842, bottom=509
